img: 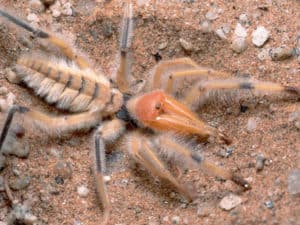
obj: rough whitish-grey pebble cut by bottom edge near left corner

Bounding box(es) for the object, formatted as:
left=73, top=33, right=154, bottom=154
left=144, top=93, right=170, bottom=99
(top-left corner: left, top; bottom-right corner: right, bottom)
left=7, top=204, right=37, bottom=225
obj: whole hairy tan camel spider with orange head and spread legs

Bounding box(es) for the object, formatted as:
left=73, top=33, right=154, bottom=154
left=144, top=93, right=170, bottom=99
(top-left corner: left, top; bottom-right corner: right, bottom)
left=0, top=3, right=300, bottom=221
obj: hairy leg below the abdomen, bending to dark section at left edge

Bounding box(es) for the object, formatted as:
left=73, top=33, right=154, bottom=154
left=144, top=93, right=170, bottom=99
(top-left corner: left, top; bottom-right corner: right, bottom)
left=0, top=105, right=101, bottom=151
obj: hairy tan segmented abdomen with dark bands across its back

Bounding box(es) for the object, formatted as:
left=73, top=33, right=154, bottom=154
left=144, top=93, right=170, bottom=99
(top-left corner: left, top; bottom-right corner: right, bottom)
left=16, top=56, right=111, bottom=112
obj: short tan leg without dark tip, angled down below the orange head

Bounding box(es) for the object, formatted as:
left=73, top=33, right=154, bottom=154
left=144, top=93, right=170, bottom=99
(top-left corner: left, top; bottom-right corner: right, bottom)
left=128, top=134, right=195, bottom=201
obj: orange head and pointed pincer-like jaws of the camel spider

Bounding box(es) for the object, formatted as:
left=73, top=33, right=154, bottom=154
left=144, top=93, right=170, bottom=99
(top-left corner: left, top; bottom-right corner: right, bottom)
left=127, top=90, right=230, bottom=144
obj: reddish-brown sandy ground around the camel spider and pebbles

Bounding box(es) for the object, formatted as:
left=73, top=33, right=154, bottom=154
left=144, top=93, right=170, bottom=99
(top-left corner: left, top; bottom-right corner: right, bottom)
left=0, top=0, right=300, bottom=225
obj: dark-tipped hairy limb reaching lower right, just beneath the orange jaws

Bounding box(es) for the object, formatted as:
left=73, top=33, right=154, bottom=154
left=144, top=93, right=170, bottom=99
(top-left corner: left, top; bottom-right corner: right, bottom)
left=156, top=135, right=250, bottom=189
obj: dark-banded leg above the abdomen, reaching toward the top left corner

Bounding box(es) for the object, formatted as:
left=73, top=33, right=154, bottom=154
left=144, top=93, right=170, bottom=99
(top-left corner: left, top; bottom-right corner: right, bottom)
left=0, top=10, right=89, bottom=69
